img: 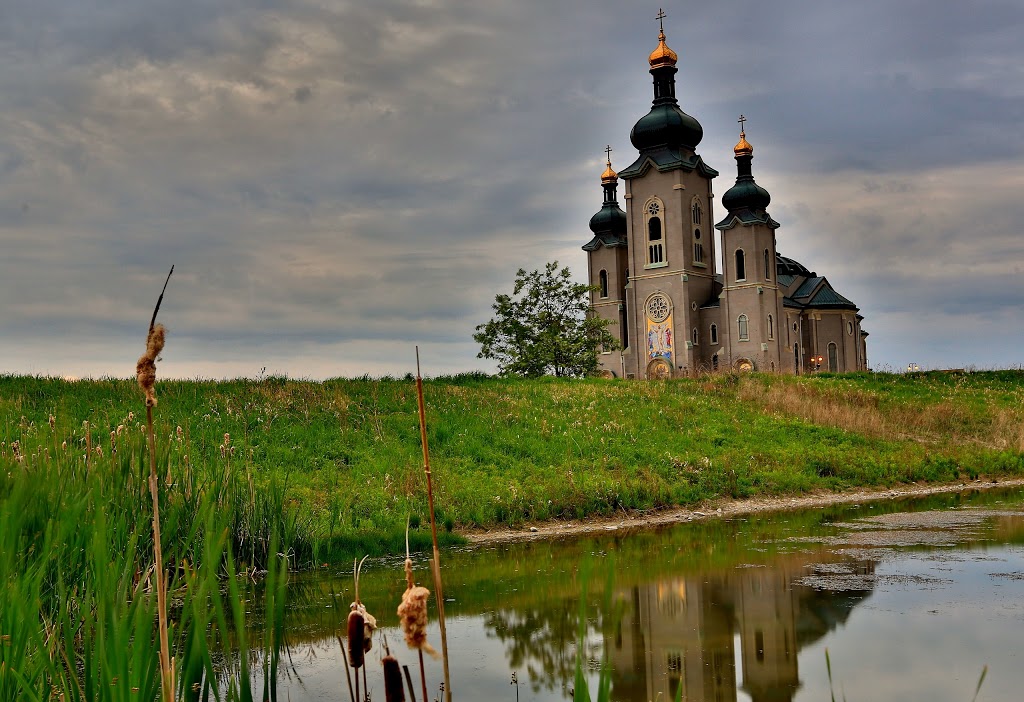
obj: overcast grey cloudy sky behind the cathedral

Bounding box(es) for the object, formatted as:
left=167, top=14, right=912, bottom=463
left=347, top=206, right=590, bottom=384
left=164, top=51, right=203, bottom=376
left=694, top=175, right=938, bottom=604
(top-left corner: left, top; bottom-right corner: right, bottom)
left=0, top=0, right=1024, bottom=378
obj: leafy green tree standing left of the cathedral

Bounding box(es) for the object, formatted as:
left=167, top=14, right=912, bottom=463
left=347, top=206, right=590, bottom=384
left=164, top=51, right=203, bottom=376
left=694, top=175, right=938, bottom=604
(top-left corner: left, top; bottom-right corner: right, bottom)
left=473, top=261, right=618, bottom=378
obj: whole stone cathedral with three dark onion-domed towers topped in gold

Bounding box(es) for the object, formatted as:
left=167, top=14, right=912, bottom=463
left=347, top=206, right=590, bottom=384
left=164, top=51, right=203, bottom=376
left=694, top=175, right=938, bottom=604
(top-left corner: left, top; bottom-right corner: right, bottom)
left=583, top=13, right=867, bottom=379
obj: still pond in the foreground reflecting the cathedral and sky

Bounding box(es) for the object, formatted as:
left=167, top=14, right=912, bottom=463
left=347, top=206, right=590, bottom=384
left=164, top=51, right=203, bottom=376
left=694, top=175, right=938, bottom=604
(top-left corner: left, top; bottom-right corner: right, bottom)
left=247, top=490, right=1024, bottom=702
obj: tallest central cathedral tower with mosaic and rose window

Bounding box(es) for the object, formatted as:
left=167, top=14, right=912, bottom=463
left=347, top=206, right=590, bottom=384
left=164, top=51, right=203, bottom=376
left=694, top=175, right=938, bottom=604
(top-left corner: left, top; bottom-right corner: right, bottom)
left=618, top=11, right=718, bottom=378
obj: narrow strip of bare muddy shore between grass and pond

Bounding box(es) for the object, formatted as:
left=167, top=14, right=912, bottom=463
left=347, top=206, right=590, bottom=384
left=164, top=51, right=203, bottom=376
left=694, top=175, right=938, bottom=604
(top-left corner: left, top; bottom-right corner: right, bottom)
left=459, top=478, right=1024, bottom=545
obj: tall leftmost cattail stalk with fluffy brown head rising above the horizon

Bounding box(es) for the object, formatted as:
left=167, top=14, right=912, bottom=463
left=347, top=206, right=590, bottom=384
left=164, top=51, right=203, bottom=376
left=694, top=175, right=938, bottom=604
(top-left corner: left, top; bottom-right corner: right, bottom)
left=135, top=266, right=174, bottom=702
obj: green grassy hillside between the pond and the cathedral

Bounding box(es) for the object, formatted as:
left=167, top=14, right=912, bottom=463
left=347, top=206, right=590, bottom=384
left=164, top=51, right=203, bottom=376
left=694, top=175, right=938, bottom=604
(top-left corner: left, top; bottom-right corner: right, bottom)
left=0, top=370, right=1024, bottom=562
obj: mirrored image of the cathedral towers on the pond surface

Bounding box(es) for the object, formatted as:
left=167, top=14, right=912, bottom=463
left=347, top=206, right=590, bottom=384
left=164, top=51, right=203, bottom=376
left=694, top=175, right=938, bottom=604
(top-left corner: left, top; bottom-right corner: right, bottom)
left=605, top=562, right=874, bottom=702
